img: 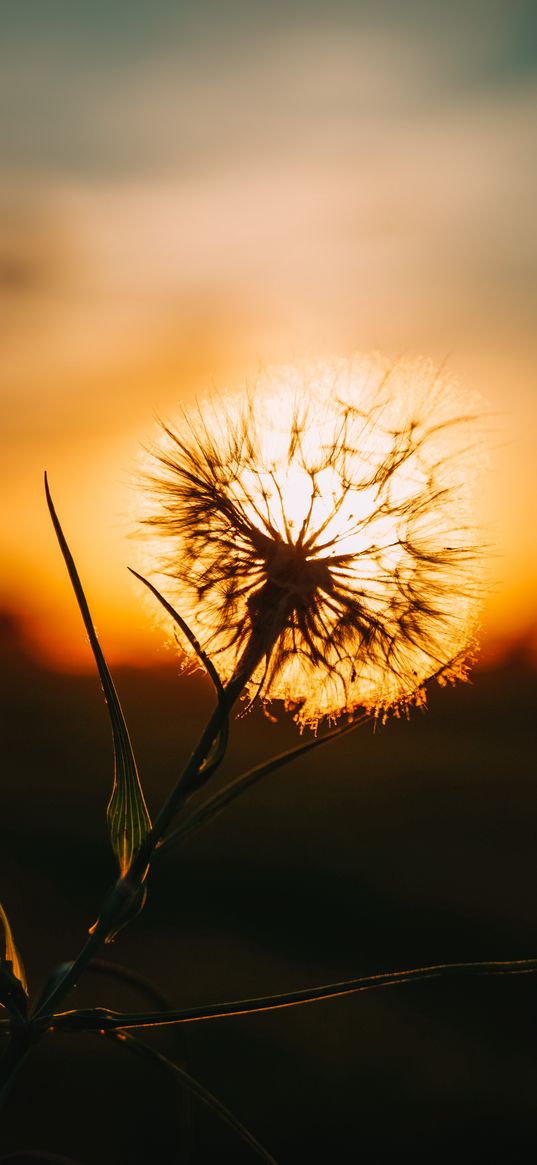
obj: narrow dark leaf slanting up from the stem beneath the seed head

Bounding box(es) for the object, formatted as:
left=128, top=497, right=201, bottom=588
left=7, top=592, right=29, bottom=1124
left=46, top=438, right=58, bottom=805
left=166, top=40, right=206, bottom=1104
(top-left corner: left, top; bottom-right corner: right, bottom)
left=158, top=715, right=373, bottom=853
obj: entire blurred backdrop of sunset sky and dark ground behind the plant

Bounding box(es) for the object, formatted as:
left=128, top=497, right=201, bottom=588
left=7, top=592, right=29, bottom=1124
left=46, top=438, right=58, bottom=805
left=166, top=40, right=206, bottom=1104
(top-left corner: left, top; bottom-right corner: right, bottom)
left=0, top=0, right=537, bottom=1165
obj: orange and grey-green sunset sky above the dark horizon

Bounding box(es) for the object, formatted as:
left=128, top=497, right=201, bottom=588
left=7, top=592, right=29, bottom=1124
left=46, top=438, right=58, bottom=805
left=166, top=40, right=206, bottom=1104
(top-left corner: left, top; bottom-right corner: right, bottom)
left=0, top=0, right=537, bottom=668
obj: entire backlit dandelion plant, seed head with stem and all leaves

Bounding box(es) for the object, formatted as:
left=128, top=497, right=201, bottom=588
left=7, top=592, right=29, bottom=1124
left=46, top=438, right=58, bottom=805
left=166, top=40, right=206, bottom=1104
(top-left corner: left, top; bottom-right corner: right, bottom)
left=0, top=358, right=528, bottom=1163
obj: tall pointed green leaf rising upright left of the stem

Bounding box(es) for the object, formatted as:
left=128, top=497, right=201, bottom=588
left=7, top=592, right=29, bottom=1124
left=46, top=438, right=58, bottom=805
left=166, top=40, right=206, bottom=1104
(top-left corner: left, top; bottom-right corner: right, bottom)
left=44, top=474, right=151, bottom=875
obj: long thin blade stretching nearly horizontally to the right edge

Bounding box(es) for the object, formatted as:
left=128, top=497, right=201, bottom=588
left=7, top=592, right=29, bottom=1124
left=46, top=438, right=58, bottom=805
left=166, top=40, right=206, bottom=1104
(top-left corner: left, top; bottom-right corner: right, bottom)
left=51, top=958, right=537, bottom=1032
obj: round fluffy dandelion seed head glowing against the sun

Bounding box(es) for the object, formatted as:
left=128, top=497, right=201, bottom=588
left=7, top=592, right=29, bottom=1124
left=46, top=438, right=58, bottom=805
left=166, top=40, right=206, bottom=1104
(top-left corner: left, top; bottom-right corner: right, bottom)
left=144, top=356, right=482, bottom=726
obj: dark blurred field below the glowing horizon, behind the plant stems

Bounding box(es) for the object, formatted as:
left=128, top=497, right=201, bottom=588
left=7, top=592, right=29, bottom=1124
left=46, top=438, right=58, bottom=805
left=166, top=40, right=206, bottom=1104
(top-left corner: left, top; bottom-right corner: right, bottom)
left=1, top=633, right=537, bottom=1165
